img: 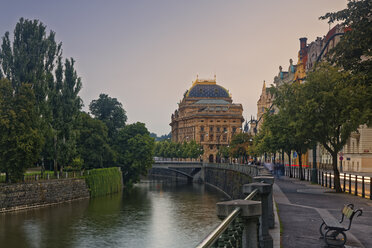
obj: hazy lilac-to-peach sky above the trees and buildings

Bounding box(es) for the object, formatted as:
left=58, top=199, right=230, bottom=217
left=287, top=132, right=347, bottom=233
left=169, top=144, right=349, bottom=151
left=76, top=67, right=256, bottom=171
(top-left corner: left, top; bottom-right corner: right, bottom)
left=0, top=0, right=347, bottom=136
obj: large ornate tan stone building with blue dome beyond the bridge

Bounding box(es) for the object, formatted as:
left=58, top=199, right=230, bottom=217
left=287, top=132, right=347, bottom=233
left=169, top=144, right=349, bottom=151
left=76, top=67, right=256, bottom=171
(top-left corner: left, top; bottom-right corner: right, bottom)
left=170, top=77, right=244, bottom=162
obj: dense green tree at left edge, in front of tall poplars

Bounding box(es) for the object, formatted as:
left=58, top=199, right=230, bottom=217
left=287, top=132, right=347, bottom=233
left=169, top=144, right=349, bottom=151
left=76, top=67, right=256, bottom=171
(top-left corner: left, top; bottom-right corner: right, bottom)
left=0, top=79, right=43, bottom=182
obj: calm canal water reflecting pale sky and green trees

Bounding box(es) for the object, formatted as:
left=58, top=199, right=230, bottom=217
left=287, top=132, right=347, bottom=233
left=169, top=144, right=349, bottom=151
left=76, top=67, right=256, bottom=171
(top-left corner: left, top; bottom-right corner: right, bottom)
left=0, top=181, right=225, bottom=248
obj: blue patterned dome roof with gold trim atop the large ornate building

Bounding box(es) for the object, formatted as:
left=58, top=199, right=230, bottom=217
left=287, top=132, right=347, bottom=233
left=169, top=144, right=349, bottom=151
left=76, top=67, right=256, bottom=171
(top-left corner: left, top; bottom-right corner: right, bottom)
left=186, top=79, right=230, bottom=98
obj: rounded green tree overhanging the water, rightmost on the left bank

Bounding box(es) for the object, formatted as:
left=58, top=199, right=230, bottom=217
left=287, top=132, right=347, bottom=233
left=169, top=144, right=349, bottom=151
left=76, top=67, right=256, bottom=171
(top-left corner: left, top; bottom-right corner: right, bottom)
left=114, top=122, right=154, bottom=185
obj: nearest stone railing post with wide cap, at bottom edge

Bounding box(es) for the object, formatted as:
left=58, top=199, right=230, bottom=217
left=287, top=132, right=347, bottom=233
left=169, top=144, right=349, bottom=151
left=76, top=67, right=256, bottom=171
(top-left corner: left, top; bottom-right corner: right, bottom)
left=217, top=200, right=262, bottom=248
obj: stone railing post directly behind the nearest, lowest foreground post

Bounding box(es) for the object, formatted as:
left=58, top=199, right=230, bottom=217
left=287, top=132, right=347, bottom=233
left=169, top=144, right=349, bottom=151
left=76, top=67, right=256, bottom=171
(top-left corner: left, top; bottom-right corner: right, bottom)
left=243, top=183, right=273, bottom=248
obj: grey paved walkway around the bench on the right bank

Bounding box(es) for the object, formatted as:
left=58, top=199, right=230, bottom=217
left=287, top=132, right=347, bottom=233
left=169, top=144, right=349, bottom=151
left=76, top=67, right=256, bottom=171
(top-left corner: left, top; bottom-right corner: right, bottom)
left=274, top=177, right=372, bottom=248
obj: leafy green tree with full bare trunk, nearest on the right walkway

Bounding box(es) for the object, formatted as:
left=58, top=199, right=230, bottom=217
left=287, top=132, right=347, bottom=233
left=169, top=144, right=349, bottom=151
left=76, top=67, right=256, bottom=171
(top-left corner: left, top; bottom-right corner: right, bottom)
left=300, top=63, right=370, bottom=192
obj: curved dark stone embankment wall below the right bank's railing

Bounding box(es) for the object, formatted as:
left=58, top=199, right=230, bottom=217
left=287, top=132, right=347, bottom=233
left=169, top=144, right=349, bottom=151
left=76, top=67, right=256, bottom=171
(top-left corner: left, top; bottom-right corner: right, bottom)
left=204, top=168, right=252, bottom=199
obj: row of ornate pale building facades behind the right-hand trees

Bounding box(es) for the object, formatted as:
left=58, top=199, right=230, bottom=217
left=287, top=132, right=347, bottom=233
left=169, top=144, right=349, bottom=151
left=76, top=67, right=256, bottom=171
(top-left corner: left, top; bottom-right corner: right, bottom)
left=251, top=25, right=372, bottom=172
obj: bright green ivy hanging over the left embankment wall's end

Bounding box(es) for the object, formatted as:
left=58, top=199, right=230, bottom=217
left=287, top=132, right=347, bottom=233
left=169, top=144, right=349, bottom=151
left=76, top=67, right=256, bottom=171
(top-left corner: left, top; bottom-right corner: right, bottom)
left=85, top=167, right=123, bottom=197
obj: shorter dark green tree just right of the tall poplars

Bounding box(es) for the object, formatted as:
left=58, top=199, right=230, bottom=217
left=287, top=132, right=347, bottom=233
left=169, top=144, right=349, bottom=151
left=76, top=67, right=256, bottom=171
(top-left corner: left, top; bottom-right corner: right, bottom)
left=76, top=113, right=115, bottom=169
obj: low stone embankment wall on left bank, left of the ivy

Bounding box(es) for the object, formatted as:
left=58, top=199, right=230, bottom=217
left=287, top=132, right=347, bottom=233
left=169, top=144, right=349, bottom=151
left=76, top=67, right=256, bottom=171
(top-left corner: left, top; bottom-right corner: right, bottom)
left=0, top=178, right=89, bottom=213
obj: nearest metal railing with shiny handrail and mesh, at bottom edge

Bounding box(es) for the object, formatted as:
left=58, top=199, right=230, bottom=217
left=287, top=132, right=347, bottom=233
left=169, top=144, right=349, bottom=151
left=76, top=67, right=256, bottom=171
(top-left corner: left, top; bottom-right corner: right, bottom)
left=196, top=189, right=258, bottom=248
